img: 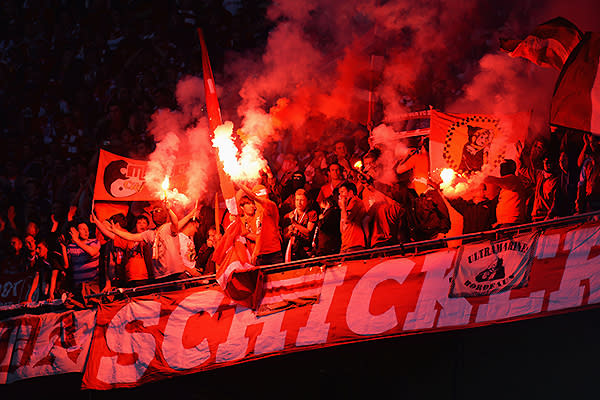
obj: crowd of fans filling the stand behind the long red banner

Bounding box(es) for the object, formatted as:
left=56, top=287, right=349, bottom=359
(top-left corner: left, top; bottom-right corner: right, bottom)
left=0, top=0, right=600, bottom=302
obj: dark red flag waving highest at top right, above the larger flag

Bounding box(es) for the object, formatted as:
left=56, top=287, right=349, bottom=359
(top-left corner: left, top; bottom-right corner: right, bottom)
left=500, top=17, right=583, bottom=71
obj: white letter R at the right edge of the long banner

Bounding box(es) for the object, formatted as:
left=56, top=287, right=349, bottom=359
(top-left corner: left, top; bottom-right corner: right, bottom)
left=548, top=226, right=600, bottom=311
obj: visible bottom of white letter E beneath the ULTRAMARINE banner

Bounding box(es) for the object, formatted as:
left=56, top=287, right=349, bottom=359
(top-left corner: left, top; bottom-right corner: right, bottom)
left=475, top=290, right=546, bottom=322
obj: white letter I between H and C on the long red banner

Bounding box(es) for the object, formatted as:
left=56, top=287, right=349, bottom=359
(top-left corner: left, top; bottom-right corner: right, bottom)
left=296, top=265, right=347, bottom=347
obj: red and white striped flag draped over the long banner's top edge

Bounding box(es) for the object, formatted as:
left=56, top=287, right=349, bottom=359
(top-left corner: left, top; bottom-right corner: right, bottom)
left=256, top=266, right=325, bottom=316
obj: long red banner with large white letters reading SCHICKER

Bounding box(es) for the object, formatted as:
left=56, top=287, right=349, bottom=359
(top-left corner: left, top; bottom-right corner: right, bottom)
left=83, top=220, right=600, bottom=389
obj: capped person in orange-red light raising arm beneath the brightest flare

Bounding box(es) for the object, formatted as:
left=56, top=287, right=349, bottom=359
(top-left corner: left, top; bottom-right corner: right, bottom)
left=238, top=184, right=283, bottom=265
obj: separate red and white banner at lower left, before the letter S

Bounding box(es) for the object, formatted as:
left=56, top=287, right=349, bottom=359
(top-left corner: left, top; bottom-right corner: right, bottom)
left=0, top=310, right=96, bottom=383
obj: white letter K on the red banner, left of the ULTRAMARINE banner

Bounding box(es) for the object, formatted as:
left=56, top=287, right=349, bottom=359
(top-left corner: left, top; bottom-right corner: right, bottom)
left=403, top=250, right=472, bottom=331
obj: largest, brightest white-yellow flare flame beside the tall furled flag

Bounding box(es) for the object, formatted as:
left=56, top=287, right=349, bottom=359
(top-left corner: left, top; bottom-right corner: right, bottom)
left=213, top=121, right=266, bottom=180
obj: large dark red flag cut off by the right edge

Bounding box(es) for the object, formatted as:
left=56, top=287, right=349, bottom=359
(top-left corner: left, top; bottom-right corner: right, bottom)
left=550, top=32, right=600, bottom=135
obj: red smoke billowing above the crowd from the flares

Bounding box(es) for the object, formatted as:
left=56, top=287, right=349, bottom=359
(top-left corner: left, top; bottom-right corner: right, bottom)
left=143, top=0, right=600, bottom=197
